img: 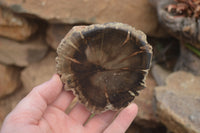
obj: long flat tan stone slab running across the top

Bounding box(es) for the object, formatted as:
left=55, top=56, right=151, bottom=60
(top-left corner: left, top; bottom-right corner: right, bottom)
left=0, top=0, right=165, bottom=36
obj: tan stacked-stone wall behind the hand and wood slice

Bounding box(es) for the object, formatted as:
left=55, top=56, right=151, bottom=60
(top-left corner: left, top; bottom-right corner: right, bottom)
left=0, top=0, right=200, bottom=133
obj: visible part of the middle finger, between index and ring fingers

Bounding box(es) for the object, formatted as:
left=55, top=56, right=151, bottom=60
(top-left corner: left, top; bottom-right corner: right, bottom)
left=69, top=103, right=91, bottom=124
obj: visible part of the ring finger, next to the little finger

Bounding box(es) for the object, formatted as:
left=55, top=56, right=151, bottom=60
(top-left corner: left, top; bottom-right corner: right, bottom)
left=85, top=111, right=116, bottom=133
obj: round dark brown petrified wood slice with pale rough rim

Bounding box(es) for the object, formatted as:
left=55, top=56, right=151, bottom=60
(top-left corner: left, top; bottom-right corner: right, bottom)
left=56, top=23, right=152, bottom=113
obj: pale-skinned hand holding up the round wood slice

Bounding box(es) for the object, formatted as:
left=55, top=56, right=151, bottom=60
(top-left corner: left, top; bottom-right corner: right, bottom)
left=0, top=74, right=138, bottom=133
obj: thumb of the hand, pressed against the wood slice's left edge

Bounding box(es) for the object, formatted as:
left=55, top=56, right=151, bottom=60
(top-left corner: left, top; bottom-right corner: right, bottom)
left=8, top=74, right=62, bottom=122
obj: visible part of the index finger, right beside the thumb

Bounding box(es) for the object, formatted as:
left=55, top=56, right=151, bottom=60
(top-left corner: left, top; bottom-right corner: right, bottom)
left=52, top=90, right=74, bottom=111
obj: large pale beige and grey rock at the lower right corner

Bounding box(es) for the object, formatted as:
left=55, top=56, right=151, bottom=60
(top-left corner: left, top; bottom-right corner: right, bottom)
left=155, top=71, right=200, bottom=133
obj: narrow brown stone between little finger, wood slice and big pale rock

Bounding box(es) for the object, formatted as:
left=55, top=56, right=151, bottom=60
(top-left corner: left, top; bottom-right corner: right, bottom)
left=134, top=73, right=159, bottom=127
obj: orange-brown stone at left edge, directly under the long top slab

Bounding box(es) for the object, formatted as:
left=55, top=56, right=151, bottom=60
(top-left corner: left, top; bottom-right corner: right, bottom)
left=0, top=6, right=37, bottom=41
